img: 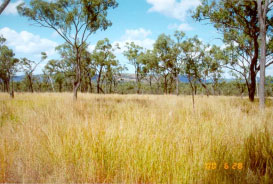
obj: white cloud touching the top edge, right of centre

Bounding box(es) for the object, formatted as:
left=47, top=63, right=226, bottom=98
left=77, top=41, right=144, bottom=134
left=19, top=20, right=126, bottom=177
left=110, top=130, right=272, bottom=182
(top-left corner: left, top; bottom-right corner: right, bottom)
left=146, top=0, right=200, bottom=21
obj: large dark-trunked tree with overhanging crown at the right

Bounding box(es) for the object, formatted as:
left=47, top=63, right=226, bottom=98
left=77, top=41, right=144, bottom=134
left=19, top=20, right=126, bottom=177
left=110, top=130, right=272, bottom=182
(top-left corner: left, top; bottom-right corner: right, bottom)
left=193, top=0, right=273, bottom=101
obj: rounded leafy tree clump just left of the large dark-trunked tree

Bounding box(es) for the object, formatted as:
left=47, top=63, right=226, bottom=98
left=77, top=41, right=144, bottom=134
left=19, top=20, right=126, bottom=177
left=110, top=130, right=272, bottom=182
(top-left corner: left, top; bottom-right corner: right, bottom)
left=182, top=36, right=221, bottom=95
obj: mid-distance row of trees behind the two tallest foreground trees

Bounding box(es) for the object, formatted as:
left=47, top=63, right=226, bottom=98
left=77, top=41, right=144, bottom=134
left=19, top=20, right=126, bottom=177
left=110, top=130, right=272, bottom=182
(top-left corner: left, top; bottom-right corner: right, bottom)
left=0, top=31, right=273, bottom=96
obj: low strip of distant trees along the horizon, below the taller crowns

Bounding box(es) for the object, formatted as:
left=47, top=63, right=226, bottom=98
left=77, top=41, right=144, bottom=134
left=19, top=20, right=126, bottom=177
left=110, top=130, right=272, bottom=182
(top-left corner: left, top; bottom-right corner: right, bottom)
left=0, top=74, right=273, bottom=97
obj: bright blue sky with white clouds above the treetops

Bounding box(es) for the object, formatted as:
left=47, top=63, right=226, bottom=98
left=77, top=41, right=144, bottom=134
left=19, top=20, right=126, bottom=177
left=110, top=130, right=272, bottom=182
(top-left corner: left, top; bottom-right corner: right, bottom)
left=0, top=0, right=270, bottom=74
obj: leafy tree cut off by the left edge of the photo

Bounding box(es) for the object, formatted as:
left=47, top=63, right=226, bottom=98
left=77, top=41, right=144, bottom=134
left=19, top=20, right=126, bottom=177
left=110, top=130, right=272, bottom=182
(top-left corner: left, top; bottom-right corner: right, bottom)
left=0, top=36, right=19, bottom=98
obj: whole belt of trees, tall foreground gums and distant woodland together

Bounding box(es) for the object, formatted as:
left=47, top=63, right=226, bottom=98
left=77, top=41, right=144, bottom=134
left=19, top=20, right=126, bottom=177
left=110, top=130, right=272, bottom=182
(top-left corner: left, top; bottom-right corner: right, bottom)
left=0, top=0, right=273, bottom=101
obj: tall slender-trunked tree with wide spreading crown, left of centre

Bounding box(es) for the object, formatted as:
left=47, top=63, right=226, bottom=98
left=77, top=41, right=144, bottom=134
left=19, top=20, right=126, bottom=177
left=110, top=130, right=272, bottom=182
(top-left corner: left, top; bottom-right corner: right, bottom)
left=17, top=0, right=118, bottom=100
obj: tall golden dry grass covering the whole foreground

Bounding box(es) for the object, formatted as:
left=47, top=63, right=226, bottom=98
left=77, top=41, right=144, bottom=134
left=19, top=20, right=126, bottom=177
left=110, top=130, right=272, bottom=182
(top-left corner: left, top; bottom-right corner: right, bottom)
left=0, top=93, right=273, bottom=183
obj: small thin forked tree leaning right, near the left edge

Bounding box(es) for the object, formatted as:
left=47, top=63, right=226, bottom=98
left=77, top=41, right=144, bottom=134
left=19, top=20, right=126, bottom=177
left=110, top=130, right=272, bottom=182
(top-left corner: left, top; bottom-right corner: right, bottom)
left=20, top=52, right=47, bottom=93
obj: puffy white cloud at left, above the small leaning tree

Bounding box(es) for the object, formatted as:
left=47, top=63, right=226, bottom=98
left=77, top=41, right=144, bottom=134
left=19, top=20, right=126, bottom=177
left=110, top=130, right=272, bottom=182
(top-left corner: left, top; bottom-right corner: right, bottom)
left=0, top=27, right=58, bottom=56
